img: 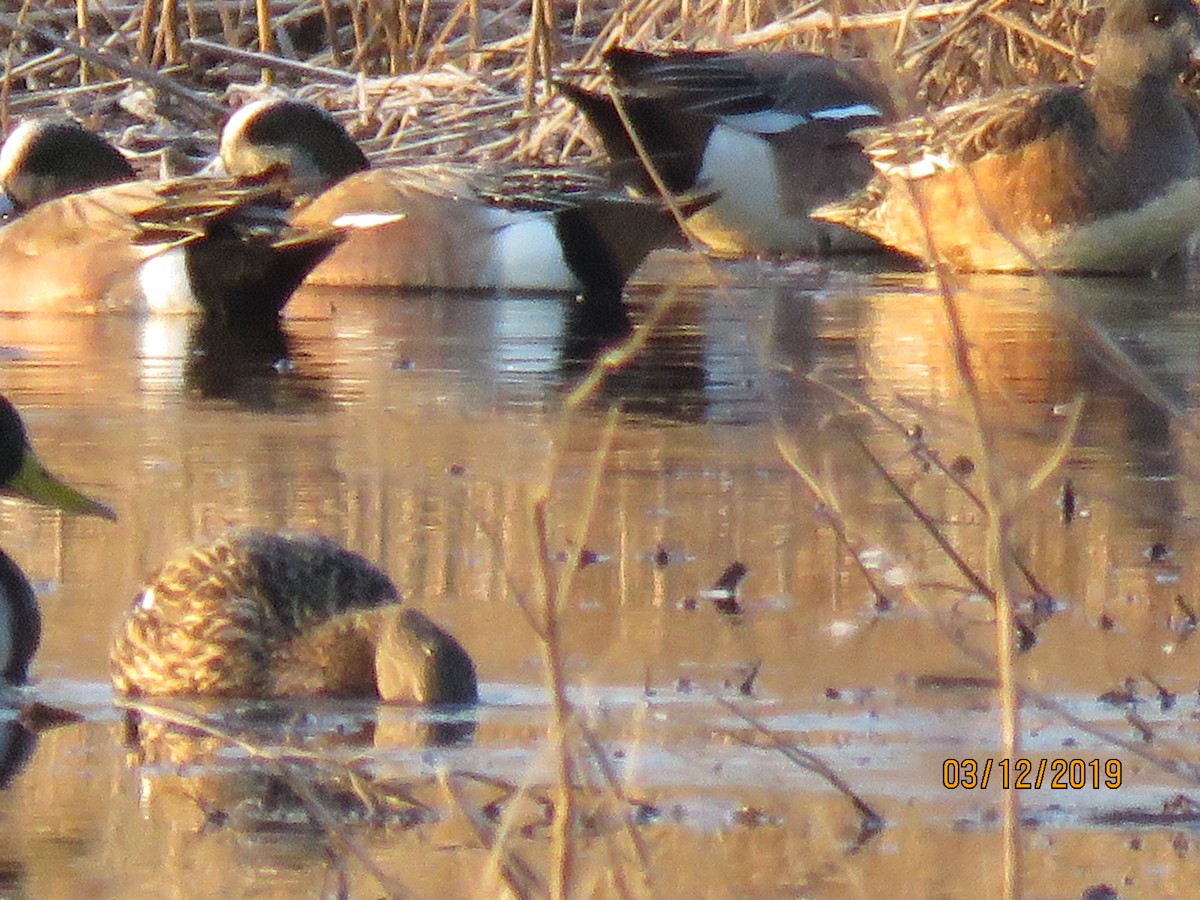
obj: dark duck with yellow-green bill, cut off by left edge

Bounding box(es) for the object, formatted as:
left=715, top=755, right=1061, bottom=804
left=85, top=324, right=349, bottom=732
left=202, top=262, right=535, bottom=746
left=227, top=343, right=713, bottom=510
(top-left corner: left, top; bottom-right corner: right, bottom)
left=0, top=395, right=116, bottom=685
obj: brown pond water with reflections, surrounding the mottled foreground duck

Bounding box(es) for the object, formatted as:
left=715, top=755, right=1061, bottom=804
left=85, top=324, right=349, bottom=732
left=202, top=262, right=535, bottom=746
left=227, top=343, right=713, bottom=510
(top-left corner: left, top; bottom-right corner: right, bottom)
left=0, top=254, right=1200, bottom=898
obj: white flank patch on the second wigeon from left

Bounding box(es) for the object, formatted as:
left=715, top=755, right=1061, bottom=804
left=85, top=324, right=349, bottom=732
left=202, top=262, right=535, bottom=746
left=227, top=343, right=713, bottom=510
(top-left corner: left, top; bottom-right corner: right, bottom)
left=487, top=209, right=583, bottom=293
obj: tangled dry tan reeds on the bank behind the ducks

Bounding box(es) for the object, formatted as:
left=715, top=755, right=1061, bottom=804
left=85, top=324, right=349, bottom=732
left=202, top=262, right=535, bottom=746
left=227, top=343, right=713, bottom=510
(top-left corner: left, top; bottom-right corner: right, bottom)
left=0, top=0, right=1099, bottom=174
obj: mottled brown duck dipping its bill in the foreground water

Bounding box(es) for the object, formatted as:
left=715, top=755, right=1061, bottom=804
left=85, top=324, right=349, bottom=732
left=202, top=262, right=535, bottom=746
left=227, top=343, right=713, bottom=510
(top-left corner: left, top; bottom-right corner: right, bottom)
left=109, top=528, right=479, bottom=706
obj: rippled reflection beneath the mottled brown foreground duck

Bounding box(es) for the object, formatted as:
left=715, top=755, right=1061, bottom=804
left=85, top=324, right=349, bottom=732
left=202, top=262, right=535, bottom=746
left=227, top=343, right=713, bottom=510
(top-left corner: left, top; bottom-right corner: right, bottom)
left=119, top=701, right=475, bottom=850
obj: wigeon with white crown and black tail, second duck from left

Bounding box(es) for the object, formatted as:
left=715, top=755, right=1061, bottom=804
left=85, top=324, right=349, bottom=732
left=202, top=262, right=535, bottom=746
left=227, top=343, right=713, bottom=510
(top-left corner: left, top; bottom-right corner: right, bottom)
left=220, top=98, right=708, bottom=302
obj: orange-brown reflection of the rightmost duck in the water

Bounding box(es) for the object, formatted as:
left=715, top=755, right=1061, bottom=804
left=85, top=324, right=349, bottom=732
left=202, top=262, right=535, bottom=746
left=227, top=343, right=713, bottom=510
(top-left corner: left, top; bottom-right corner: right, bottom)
left=858, top=275, right=1198, bottom=554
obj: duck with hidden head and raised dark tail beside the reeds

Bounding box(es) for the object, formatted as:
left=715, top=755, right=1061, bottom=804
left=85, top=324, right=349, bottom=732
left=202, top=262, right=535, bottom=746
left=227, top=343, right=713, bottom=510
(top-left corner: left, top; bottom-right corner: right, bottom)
left=559, top=47, right=892, bottom=256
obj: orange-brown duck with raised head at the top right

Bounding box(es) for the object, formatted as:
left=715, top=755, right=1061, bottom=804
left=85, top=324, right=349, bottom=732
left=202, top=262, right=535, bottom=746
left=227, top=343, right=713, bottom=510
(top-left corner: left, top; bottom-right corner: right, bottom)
left=814, top=0, right=1200, bottom=275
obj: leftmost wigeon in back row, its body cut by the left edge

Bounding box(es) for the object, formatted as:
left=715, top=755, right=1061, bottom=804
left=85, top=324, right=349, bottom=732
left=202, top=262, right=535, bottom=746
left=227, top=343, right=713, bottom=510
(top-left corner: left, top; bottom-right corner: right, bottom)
left=0, top=119, right=343, bottom=322
